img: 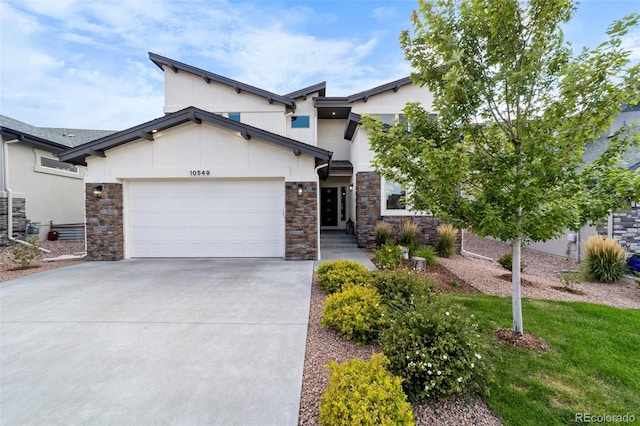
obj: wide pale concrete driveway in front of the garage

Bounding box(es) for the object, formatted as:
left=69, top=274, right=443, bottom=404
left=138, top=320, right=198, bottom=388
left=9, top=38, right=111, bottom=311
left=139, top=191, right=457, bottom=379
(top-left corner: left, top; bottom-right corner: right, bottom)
left=0, top=259, right=313, bottom=426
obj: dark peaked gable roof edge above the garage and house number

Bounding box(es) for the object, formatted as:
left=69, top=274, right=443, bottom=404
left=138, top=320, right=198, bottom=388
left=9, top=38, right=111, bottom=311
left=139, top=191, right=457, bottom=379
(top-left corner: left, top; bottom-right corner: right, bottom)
left=59, top=107, right=333, bottom=176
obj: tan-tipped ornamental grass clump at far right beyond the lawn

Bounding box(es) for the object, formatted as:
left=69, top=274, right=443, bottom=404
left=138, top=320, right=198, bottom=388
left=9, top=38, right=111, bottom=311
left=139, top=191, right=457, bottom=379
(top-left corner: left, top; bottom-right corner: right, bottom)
left=584, top=235, right=627, bottom=283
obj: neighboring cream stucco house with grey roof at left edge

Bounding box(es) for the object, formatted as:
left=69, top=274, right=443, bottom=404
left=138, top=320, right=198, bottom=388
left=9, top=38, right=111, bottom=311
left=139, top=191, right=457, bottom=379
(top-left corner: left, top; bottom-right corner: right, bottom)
left=0, top=115, right=112, bottom=244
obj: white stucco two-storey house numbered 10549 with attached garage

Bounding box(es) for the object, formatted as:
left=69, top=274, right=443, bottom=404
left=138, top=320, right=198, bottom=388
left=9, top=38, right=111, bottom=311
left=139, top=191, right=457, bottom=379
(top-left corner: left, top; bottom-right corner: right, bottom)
left=60, top=53, right=438, bottom=260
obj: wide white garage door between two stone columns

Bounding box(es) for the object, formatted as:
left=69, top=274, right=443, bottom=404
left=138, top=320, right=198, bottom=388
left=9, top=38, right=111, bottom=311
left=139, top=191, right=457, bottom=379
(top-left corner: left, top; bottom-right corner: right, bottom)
left=125, top=180, right=285, bottom=257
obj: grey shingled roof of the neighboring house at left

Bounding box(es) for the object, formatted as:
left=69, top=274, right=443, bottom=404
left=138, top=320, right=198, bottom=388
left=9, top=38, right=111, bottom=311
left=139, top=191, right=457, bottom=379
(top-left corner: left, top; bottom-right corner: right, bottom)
left=0, top=115, right=113, bottom=152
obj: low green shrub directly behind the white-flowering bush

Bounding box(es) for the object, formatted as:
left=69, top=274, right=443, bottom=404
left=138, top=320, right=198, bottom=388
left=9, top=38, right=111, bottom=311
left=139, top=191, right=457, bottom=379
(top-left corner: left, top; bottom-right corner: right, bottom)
left=369, top=269, right=435, bottom=309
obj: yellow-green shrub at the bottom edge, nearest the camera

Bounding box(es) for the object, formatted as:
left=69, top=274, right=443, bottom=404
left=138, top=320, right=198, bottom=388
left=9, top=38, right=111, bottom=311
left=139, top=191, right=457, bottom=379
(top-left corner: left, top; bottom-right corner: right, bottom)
left=319, top=354, right=414, bottom=426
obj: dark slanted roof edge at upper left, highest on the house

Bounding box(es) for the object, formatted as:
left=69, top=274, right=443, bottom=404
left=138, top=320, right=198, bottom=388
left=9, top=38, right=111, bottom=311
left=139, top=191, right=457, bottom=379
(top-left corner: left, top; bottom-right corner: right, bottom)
left=149, top=52, right=296, bottom=111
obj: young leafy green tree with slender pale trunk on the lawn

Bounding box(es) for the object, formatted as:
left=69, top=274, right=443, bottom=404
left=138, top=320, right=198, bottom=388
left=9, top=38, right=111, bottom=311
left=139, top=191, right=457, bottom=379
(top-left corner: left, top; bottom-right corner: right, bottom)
left=363, top=0, right=640, bottom=334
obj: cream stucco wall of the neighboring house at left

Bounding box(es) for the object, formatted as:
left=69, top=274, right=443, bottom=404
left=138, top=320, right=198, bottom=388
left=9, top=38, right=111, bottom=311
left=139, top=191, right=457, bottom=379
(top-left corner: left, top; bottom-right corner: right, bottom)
left=0, top=143, right=86, bottom=240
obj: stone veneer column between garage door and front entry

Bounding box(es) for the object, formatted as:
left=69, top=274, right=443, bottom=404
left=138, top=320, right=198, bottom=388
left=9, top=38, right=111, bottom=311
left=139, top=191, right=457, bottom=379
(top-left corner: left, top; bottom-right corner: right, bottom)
left=285, top=182, right=318, bottom=260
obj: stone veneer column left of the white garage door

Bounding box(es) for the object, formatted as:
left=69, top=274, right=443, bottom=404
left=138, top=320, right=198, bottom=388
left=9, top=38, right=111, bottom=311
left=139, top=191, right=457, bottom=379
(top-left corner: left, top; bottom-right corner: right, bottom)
left=85, top=183, right=124, bottom=260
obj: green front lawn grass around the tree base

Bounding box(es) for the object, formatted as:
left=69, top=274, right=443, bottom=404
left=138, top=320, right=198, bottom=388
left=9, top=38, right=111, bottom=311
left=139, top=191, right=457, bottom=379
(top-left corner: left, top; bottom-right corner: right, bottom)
left=447, top=294, right=640, bottom=425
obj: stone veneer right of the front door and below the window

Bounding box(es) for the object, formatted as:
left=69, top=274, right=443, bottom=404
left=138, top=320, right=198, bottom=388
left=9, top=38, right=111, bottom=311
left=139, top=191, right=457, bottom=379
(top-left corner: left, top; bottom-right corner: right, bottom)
left=356, top=172, right=444, bottom=251
